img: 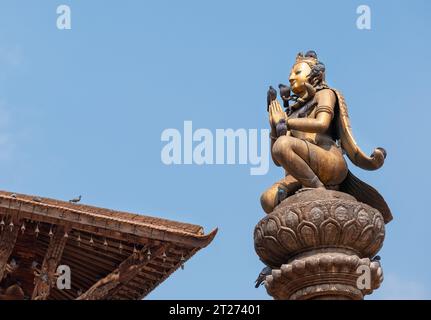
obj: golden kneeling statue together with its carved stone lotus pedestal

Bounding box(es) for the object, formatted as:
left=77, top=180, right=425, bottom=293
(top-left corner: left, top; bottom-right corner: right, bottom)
left=254, top=51, right=392, bottom=300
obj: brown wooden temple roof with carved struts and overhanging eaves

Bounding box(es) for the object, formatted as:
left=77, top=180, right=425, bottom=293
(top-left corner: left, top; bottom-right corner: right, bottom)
left=0, top=191, right=217, bottom=299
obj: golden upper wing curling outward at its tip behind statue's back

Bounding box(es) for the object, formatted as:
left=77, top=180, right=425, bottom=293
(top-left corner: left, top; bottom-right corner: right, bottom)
left=332, top=89, right=386, bottom=170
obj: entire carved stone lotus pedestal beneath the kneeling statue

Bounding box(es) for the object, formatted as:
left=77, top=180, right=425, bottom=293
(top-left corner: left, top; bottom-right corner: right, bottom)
left=254, top=189, right=385, bottom=300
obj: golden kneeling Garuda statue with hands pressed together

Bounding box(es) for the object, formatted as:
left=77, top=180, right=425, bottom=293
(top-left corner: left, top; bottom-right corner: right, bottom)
left=261, top=51, right=392, bottom=223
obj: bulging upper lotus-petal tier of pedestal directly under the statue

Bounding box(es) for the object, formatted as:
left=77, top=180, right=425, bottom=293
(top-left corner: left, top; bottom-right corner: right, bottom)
left=254, top=190, right=385, bottom=267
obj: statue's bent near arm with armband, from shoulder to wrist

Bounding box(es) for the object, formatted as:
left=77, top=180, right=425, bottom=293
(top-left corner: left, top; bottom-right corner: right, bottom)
left=287, top=89, right=336, bottom=133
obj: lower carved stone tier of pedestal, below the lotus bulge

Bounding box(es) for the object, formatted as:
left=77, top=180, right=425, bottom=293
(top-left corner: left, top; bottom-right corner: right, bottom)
left=265, top=252, right=383, bottom=300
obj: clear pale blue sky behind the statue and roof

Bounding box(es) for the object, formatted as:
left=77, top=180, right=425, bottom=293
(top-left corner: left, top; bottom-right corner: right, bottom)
left=0, top=0, right=431, bottom=299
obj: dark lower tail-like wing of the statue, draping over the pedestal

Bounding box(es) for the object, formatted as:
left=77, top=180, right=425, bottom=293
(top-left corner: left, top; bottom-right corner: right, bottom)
left=340, top=170, right=392, bottom=223
